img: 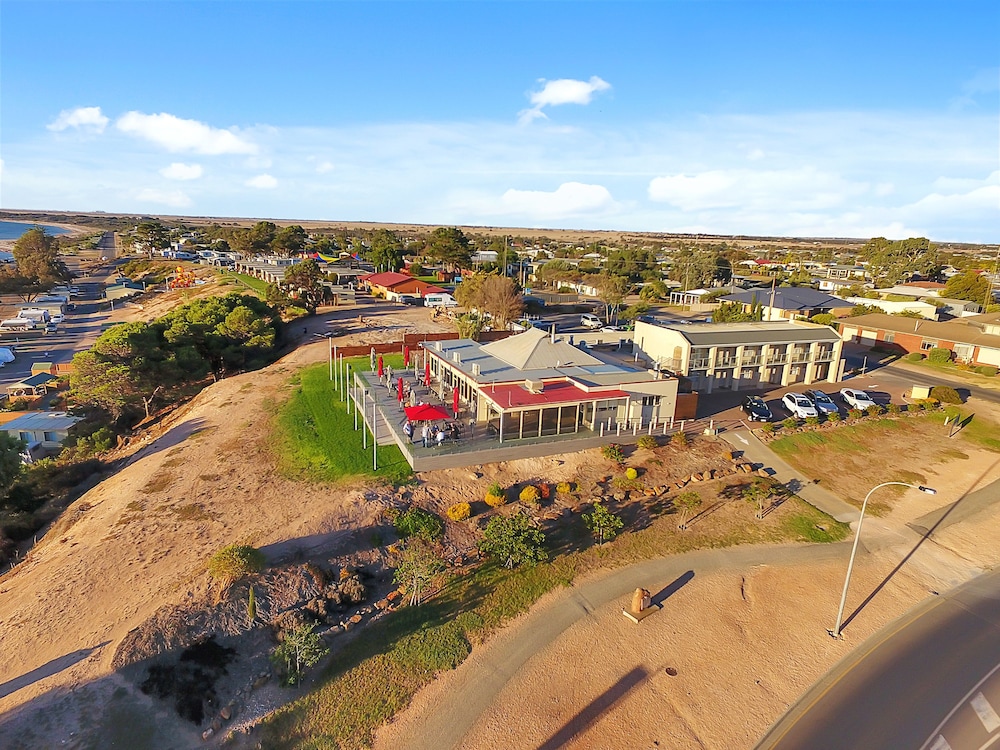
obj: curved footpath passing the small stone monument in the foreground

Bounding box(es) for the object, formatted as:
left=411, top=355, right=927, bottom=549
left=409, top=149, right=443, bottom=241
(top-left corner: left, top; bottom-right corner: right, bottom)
left=394, top=542, right=848, bottom=750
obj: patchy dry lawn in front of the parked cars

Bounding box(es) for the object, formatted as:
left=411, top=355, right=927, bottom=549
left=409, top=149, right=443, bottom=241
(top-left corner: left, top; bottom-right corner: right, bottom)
left=770, top=407, right=1000, bottom=514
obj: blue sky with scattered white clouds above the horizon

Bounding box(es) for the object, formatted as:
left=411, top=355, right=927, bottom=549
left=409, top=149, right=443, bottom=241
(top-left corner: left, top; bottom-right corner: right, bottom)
left=0, top=0, right=1000, bottom=243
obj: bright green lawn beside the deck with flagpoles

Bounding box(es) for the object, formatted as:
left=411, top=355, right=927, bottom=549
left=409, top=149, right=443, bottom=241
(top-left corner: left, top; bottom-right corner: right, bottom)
left=273, top=364, right=412, bottom=483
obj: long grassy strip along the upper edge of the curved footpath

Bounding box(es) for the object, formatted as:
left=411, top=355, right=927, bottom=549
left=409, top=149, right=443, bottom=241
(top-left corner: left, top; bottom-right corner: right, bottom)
left=262, top=484, right=849, bottom=750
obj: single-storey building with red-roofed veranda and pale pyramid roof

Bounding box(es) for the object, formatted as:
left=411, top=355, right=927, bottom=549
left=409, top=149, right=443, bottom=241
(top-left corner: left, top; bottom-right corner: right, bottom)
left=424, top=328, right=680, bottom=444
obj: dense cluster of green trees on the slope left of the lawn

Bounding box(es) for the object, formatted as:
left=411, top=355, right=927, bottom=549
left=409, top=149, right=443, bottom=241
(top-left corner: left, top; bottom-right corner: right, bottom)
left=70, top=294, right=280, bottom=420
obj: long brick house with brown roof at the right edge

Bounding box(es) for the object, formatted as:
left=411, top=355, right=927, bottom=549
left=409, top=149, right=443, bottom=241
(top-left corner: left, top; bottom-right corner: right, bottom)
left=837, top=313, right=1000, bottom=366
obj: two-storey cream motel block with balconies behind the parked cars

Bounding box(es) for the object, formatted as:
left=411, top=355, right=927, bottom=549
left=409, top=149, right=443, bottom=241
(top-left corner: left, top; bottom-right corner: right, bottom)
left=633, top=320, right=842, bottom=393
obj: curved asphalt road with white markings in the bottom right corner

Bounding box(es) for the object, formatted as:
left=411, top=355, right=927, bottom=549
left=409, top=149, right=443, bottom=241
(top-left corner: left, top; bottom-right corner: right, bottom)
left=758, top=571, right=1000, bottom=750
